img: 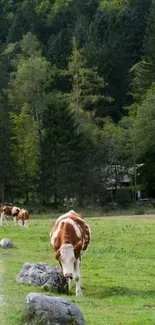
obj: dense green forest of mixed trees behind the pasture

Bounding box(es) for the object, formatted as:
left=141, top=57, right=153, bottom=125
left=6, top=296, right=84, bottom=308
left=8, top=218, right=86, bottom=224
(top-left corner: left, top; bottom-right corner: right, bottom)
left=0, top=0, right=155, bottom=207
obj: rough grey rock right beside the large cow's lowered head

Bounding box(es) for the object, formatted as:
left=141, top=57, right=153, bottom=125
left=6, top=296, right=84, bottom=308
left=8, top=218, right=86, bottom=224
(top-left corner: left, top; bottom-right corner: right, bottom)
left=16, top=263, right=68, bottom=293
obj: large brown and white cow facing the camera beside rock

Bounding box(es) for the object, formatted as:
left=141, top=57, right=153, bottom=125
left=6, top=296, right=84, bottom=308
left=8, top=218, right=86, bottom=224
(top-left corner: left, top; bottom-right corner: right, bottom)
left=50, top=210, right=90, bottom=296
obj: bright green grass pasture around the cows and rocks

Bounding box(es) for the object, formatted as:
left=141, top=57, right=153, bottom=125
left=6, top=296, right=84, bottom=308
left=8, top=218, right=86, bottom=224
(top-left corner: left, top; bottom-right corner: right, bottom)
left=0, top=214, right=155, bottom=325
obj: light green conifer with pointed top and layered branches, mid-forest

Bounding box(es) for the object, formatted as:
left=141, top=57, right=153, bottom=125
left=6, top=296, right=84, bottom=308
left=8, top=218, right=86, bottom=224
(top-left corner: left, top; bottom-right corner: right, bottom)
left=68, top=39, right=110, bottom=128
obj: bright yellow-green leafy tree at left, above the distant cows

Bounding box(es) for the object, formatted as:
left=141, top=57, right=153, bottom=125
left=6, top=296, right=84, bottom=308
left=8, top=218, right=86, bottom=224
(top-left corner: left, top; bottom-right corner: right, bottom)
left=11, top=105, right=40, bottom=201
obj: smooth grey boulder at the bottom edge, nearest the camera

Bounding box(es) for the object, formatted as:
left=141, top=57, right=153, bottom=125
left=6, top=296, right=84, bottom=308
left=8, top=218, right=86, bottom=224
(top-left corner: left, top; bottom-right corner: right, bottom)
left=26, top=293, right=85, bottom=325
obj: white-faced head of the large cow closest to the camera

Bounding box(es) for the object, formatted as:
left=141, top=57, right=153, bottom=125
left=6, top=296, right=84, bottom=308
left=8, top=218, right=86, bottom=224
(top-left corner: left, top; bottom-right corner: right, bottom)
left=56, top=240, right=82, bottom=279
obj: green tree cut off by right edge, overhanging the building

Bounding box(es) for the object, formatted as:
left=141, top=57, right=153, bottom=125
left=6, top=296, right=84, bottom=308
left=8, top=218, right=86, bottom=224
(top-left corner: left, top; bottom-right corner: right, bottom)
left=135, top=83, right=155, bottom=197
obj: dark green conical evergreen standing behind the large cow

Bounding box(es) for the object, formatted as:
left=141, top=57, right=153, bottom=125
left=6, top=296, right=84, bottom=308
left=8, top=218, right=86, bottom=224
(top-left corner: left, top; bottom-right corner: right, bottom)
left=41, top=97, right=91, bottom=205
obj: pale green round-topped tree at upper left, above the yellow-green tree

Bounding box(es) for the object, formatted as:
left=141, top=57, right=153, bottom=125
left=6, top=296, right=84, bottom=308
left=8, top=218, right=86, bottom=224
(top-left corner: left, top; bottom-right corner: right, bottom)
left=9, top=33, right=53, bottom=137
